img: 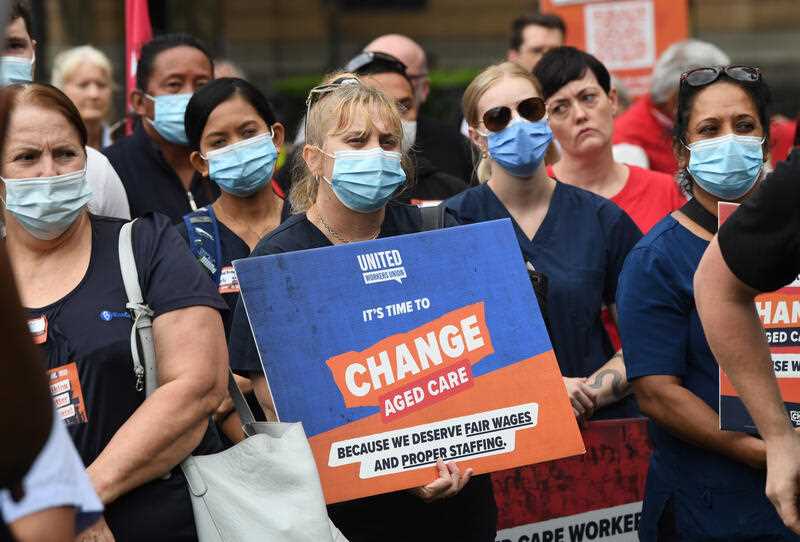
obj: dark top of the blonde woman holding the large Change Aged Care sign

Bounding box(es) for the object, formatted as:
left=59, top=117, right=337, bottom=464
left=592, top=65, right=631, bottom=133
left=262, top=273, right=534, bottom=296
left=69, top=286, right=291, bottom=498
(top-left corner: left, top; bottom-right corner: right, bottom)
left=229, top=203, right=497, bottom=542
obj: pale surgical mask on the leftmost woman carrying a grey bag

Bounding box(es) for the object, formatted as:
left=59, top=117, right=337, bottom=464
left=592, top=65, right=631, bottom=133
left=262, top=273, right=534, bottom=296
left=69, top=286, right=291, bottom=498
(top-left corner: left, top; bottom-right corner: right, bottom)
left=3, top=169, right=92, bottom=240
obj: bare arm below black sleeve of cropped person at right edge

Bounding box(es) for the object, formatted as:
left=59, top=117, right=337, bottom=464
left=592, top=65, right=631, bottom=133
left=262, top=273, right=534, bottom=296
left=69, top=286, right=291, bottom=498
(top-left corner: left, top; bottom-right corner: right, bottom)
left=694, top=237, right=800, bottom=533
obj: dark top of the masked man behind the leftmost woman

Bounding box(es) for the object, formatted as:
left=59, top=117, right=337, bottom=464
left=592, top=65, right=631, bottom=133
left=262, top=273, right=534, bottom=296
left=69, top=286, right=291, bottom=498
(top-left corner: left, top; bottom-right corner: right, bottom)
left=103, top=123, right=219, bottom=224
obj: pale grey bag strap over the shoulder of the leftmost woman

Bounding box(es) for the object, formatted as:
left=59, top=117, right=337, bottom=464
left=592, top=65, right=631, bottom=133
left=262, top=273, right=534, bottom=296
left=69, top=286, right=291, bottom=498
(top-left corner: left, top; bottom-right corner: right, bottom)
left=119, top=220, right=255, bottom=424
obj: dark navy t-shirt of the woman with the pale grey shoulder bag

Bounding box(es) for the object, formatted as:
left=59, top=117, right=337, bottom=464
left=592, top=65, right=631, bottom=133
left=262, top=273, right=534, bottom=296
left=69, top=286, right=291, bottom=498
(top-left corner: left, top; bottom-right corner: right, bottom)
left=28, top=215, right=225, bottom=541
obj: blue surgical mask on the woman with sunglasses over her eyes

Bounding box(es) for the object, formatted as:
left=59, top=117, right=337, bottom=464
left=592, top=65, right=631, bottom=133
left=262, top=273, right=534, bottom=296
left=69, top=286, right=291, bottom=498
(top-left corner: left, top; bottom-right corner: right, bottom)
left=487, top=118, right=553, bottom=178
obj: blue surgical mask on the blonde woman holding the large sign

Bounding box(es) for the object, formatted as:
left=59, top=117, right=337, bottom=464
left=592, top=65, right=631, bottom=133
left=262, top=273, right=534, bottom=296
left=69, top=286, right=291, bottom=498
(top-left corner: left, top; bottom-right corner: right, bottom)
left=320, top=147, right=406, bottom=213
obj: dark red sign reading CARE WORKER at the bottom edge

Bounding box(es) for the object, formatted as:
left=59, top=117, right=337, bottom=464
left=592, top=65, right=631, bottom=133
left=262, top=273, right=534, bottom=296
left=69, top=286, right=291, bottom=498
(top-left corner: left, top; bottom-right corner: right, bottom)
left=492, top=418, right=652, bottom=542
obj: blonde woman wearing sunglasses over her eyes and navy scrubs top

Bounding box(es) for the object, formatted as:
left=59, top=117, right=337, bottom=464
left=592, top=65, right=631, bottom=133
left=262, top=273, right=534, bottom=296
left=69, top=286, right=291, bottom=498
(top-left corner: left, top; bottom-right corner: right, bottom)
left=445, top=62, right=642, bottom=419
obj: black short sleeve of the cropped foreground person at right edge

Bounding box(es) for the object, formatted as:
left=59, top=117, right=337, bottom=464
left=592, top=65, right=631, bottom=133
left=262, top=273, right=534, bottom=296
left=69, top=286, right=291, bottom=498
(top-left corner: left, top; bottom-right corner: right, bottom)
left=719, top=150, right=800, bottom=292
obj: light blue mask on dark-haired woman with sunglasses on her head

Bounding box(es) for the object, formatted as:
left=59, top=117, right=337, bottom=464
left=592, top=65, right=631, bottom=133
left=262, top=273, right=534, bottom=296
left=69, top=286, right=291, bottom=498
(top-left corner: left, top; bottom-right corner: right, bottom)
left=686, top=134, right=764, bottom=201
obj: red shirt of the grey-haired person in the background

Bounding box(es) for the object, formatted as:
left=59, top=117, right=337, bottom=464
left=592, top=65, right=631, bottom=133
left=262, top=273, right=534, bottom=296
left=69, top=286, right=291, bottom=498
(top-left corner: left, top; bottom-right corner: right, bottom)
left=613, top=94, right=678, bottom=175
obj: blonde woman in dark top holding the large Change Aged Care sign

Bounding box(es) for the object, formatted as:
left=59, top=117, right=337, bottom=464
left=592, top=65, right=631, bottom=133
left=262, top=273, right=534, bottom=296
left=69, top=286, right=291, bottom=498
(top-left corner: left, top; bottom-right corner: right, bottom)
left=230, top=73, right=496, bottom=542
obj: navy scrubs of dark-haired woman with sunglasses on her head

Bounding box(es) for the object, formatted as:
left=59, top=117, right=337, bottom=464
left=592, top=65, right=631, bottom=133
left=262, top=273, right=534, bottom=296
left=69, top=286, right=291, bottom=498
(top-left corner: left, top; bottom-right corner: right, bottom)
left=617, top=216, right=800, bottom=542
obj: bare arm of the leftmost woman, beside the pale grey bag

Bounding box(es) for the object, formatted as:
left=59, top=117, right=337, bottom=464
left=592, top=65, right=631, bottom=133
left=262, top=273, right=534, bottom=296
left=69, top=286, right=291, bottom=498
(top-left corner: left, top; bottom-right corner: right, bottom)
left=87, top=306, right=228, bottom=504
